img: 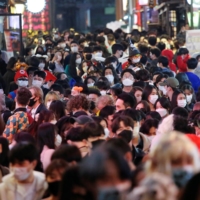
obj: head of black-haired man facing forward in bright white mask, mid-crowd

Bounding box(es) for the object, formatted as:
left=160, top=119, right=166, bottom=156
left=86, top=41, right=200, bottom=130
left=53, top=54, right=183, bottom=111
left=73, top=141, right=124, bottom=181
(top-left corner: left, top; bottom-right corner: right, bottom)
left=121, top=69, right=135, bottom=93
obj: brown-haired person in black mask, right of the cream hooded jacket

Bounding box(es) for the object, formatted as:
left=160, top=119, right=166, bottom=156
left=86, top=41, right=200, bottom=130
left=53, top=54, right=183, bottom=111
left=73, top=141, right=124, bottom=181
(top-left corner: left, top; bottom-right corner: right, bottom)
left=45, top=159, right=69, bottom=200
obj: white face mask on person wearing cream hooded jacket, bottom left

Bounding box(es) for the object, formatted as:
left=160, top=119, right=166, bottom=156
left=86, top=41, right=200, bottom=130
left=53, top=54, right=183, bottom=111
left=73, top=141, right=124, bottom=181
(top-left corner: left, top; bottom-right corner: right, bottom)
left=11, top=167, right=31, bottom=181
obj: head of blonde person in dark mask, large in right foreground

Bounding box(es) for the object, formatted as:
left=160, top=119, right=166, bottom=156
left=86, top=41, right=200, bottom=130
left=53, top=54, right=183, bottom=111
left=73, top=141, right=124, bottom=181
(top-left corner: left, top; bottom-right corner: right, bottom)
left=146, top=131, right=200, bottom=187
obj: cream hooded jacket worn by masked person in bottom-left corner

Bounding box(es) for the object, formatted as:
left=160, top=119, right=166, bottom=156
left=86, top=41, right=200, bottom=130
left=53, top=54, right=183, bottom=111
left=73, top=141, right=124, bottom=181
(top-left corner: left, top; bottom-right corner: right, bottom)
left=0, top=171, right=47, bottom=200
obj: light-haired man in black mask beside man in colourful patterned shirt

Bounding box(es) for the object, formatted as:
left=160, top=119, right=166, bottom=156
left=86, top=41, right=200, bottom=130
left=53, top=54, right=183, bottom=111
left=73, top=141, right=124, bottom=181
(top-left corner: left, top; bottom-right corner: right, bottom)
left=28, top=86, right=47, bottom=119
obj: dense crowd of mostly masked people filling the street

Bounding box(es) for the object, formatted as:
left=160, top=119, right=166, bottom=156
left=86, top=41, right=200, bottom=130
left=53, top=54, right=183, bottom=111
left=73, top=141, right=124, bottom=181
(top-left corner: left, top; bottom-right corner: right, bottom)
left=0, top=25, right=200, bottom=200
